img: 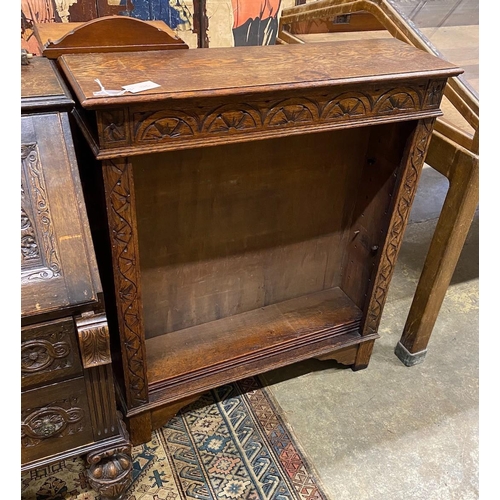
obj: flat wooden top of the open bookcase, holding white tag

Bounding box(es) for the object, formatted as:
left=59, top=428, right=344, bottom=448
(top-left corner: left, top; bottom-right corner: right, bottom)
left=59, top=39, right=462, bottom=108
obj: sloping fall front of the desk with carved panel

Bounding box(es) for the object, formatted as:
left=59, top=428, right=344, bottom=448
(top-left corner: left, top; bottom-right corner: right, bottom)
left=21, top=113, right=97, bottom=316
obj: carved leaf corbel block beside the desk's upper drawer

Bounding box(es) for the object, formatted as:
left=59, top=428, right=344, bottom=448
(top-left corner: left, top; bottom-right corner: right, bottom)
left=76, top=314, right=111, bottom=368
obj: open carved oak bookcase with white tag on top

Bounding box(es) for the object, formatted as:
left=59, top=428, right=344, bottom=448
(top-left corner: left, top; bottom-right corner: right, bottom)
left=58, top=39, right=460, bottom=443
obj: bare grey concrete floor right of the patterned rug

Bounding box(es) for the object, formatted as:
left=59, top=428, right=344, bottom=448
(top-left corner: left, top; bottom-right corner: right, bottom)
left=263, top=167, right=479, bottom=500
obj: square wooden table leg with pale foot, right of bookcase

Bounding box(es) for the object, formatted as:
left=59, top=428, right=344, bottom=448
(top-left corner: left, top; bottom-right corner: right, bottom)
left=395, top=134, right=479, bottom=366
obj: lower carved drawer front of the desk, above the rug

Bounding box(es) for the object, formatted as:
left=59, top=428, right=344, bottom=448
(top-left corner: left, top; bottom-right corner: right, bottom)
left=21, top=378, right=93, bottom=464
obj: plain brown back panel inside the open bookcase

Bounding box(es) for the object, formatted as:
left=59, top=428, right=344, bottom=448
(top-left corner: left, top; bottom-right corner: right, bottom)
left=133, top=128, right=369, bottom=337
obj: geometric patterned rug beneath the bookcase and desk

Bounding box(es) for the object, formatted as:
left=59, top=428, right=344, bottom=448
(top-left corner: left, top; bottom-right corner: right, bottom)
left=21, top=377, right=327, bottom=500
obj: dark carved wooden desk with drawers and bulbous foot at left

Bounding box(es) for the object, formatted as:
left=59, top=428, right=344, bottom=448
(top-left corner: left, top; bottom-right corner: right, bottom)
left=21, top=58, right=132, bottom=498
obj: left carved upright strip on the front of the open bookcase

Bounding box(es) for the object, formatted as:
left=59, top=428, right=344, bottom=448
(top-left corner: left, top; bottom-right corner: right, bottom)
left=103, top=160, right=148, bottom=406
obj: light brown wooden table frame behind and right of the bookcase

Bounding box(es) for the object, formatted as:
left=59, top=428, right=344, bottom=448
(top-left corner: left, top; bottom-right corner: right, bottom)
left=277, top=0, right=479, bottom=366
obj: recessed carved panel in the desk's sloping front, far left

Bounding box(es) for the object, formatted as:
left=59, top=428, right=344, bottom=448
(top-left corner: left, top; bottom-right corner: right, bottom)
left=21, top=143, right=61, bottom=283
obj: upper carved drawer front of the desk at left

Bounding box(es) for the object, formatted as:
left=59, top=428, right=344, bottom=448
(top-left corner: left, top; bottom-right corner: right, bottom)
left=21, top=318, right=82, bottom=390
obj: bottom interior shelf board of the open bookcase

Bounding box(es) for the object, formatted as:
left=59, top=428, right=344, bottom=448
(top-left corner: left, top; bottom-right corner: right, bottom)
left=146, top=288, right=361, bottom=383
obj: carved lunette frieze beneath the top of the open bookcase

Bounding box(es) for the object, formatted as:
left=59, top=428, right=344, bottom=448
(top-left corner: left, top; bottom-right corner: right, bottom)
left=111, top=82, right=443, bottom=149
